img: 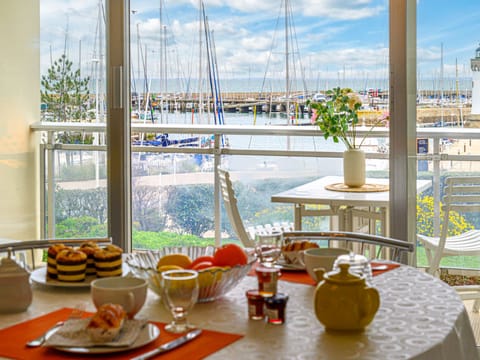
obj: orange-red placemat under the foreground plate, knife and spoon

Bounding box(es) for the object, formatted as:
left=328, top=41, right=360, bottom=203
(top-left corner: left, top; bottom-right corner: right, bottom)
left=0, top=308, right=243, bottom=360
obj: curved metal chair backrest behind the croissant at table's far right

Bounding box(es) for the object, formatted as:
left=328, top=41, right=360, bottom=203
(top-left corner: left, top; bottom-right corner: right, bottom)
left=283, top=231, right=414, bottom=262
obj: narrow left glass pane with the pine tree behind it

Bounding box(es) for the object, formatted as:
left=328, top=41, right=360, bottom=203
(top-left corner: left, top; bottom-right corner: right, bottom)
left=40, top=0, right=108, bottom=238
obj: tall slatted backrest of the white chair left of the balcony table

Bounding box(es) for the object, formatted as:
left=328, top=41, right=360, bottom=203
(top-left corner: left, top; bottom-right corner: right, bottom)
left=218, top=168, right=254, bottom=247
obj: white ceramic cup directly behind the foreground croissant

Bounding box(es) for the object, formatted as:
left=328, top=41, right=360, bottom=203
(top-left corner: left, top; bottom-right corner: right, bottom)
left=90, top=277, right=148, bottom=319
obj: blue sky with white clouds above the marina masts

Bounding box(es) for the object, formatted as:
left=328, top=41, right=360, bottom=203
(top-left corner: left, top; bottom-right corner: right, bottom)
left=40, top=0, right=480, bottom=90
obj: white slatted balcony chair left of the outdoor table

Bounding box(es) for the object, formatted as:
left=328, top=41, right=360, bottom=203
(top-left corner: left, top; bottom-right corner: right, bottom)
left=218, top=168, right=293, bottom=247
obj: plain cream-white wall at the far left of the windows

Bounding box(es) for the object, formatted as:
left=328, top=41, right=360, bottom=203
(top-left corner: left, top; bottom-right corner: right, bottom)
left=0, top=0, right=40, bottom=239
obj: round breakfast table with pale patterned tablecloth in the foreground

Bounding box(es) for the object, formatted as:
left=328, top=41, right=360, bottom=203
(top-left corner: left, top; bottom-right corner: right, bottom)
left=0, top=258, right=479, bottom=360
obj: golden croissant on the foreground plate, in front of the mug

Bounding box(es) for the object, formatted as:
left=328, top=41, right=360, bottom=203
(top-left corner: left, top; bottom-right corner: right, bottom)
left=87, top=304, right=126, bottom=343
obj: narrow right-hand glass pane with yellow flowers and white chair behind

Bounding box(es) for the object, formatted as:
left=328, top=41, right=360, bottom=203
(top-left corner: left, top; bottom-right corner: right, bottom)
left=417, top=1, right=480, bottom=278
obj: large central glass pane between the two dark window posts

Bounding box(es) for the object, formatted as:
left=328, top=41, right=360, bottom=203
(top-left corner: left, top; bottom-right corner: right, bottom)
left=130, top=0, right=389, bottom=248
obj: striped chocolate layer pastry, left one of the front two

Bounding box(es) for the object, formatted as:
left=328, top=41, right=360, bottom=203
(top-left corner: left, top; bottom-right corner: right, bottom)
left=57, top=249, right=87, bottom=282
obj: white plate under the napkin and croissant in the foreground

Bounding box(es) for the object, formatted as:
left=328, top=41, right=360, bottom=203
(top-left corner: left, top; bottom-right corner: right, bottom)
left=53, top=323, right=160, bottom=354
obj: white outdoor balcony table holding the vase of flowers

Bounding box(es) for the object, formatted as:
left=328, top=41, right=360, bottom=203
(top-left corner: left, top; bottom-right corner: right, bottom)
left=271, top=175, right=431, bottom=236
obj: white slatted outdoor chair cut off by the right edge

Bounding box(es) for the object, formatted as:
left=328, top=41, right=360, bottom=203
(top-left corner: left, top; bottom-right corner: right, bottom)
left=417, top=176, right=480, bottom=311
